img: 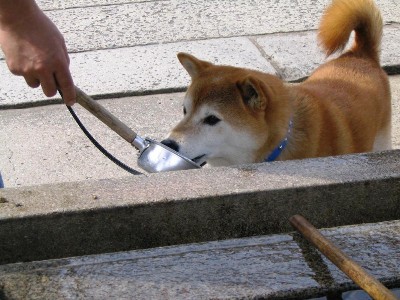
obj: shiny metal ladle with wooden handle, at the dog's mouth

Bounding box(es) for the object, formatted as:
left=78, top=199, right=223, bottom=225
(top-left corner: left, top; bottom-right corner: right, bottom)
left=75, top=87, right=201, bottom=173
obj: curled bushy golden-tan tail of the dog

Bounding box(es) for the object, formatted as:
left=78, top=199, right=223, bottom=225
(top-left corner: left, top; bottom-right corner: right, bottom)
left=318, top=0, right=383, bottom=63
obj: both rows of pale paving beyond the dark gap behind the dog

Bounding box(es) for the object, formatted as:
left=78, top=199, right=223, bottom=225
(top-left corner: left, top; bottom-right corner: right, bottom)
left=0, top=0, right=400, bottom=109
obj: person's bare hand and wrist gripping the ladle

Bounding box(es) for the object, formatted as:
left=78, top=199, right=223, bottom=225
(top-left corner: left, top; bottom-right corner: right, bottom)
left=0, top=0, right=76, bottom=105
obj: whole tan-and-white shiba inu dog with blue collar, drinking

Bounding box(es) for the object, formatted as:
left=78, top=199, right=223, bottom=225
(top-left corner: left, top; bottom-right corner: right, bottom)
left=163, top=0, right=391, bottom=166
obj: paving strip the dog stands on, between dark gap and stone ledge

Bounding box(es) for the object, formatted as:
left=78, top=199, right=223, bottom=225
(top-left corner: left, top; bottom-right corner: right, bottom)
left=0, top=76, right=400, bottom=187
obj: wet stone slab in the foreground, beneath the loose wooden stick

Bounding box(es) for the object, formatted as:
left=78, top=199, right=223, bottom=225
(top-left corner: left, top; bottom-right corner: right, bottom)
left=0, top=221, right=400, bottom=299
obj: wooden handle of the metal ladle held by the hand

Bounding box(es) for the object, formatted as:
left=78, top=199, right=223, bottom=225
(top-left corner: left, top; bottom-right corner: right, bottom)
left=75, top=87, right=137, bottom=143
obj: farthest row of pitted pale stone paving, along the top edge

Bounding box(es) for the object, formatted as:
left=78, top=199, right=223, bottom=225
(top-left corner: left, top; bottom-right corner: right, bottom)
left=34, top=0, right=400, bottom=52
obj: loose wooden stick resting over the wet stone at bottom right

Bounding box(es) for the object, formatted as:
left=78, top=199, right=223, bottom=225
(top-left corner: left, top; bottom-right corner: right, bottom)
left=289, top=215, right=397, bottom=300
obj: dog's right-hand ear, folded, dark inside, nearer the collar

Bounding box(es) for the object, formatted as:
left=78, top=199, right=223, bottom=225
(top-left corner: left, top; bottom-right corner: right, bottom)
left=236, top=76, right=270, bottom=110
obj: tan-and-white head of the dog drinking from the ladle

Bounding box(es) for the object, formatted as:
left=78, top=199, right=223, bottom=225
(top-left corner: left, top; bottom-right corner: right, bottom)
left=163, top=53, right=287, bottom=166
